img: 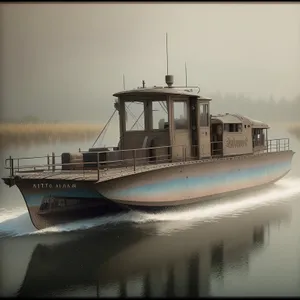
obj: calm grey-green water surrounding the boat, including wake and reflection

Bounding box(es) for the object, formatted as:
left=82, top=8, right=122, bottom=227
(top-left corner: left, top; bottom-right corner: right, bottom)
left=0, top=128, right=300, bottom=297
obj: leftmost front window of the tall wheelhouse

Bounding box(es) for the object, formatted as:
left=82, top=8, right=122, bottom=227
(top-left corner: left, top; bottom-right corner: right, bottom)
left=125, top=101, right=145, bottom=131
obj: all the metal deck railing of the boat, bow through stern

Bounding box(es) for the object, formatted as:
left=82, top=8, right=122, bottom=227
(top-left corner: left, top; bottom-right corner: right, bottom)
left=5, top=138, right=290, bottom=179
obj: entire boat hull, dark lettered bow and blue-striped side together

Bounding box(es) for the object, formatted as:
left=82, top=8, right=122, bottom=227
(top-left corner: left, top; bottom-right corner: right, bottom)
left=4, top=151, right=294, bottom=229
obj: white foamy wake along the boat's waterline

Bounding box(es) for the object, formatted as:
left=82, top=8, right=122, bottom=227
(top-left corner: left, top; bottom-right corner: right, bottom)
left=0, top=178, right=300, bottom=235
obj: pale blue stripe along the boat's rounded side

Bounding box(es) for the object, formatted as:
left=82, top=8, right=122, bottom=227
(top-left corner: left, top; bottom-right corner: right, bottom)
left=107, top=161, right=291, bottom=200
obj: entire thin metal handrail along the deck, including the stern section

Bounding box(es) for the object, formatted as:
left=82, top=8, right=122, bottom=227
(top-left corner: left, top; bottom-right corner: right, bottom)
left=4, top=138, right=290, bottom=179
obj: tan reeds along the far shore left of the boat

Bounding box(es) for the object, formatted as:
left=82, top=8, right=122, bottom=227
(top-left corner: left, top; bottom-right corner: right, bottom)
left=0, top=123, right=103, bottom=147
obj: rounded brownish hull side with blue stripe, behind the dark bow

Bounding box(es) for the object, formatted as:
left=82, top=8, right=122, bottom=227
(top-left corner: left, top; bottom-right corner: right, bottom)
left=97, top=151, right=294, bottom=209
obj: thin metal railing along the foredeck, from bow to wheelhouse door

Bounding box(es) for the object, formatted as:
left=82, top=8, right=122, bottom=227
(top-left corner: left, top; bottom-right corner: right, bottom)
left=5, top=145, right=187, bottom=179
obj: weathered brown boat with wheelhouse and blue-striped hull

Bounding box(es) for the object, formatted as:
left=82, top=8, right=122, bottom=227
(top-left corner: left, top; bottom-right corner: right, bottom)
left=3, top=75, right=294, bottom=229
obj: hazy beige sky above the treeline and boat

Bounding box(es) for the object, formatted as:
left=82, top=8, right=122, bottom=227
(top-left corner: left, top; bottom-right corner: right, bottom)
left=0, top=3, right=300, bottom=121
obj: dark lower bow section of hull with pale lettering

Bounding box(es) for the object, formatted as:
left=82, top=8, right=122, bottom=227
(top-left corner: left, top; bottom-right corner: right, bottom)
left=16, top=179, right=120, bottom=230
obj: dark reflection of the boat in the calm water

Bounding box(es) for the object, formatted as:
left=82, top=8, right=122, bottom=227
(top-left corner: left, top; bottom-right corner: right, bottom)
left=0, top=204, right=290, bottom=297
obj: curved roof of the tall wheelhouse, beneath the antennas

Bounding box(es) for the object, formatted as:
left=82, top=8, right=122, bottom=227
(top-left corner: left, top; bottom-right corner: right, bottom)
left=113, top=87, right=211, bottom=101
